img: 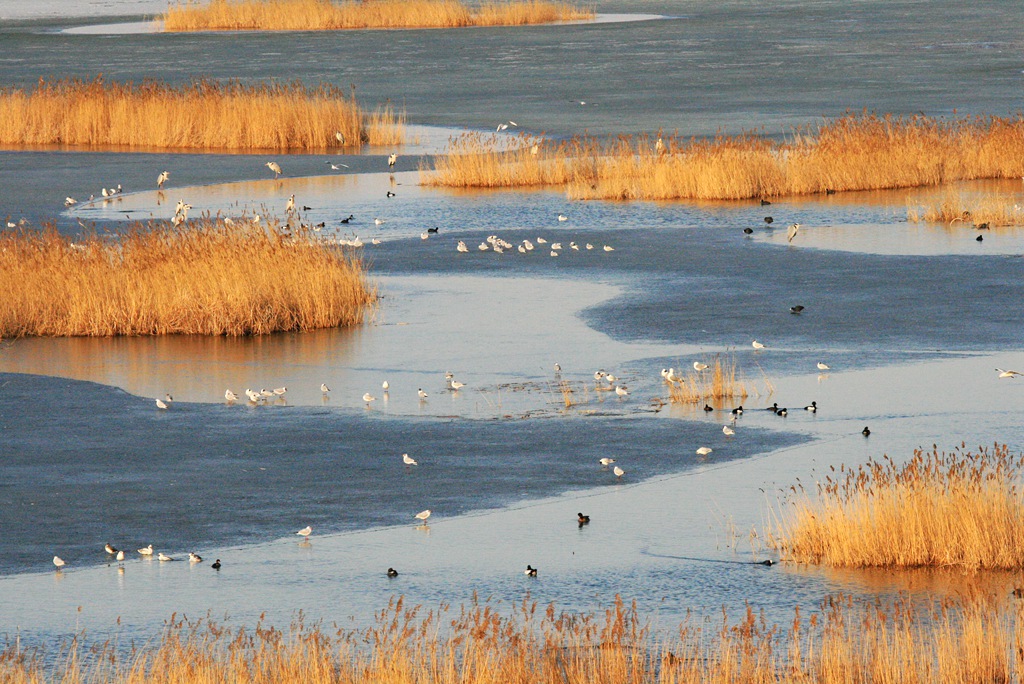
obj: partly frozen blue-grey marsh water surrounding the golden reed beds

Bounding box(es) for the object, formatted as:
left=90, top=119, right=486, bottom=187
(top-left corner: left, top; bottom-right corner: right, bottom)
left=0, top=2, right=1024, bottom=651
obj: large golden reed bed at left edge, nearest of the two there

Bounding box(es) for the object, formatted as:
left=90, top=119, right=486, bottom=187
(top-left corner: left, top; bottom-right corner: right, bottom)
left=0, top=218, right=376, bottom=337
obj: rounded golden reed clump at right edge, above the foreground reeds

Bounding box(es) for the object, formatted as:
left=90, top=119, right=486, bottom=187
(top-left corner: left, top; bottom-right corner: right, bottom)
left=770, top=445, right=1024, bottom=570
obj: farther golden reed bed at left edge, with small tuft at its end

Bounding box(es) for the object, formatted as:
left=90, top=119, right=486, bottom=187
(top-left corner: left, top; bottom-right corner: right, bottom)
left=0, top=77, right=404, bottom=152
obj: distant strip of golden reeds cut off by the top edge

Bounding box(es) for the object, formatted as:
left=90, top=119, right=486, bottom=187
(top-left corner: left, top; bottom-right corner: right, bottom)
left=164, top=0, right=594, bottom=32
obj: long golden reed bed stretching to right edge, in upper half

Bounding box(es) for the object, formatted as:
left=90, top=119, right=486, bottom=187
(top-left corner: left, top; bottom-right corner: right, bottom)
left=421, top=114, right=1024, bottom=200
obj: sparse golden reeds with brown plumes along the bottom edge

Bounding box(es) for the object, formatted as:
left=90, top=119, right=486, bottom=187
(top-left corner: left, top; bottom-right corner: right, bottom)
left=0, top=596, right=1024, bottom=684
